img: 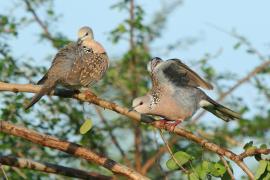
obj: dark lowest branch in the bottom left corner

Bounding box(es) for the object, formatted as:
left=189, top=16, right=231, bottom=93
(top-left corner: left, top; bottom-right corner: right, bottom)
left=0, top=156, right=112, bottom=180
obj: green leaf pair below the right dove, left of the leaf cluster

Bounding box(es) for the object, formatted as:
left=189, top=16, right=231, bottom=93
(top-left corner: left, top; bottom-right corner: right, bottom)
left=166, top=151, right=194, bottom=170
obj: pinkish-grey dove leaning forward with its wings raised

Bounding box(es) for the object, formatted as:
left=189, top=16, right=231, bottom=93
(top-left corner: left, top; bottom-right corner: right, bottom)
left=132, top=57, right=240, bottom=128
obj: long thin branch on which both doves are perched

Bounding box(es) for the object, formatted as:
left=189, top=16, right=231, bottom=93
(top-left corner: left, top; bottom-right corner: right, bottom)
left=0, top=83, right=270, bottom=179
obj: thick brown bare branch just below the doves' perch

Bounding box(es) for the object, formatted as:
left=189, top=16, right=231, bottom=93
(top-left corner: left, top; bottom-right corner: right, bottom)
left=0, top=120, right=148, bottom=180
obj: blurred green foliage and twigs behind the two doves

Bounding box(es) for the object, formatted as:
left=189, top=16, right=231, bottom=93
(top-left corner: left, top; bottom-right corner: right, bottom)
left=0, top=0, right=270, bottom=179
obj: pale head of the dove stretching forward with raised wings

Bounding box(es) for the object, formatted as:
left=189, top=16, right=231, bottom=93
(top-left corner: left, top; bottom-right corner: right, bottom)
left=130, top=95, right=151, bottom=114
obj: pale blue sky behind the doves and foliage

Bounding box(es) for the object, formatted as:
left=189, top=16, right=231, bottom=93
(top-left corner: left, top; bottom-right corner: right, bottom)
left=0, top=0, right=270, bottom=177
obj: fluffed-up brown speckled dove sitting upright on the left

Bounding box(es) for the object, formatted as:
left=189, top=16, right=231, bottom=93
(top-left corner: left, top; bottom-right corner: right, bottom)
left=25, top=27, right=109, bottom=109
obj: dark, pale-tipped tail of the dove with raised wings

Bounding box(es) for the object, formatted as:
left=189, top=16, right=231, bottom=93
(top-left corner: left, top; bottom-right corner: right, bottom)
left=200, top=97, right=241, bottom=122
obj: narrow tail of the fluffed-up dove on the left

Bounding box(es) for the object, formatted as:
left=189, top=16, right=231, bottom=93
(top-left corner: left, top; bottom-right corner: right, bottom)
left=24, top=81, right=56, bottom=110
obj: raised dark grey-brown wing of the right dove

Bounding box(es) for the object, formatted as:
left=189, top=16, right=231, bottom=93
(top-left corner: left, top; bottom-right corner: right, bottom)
left=162, top=59, right=213, bottom=89
